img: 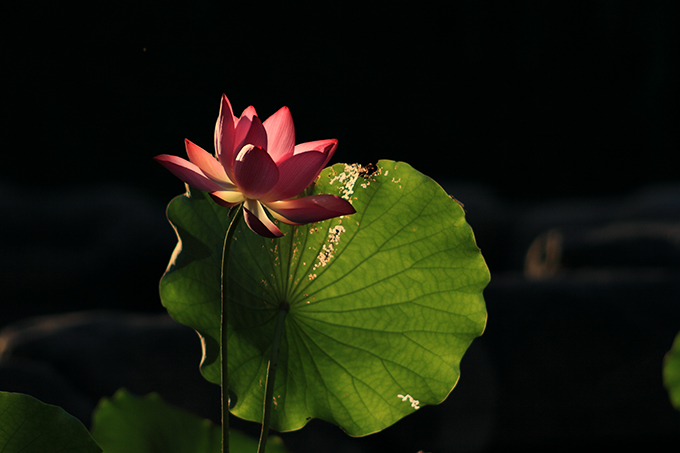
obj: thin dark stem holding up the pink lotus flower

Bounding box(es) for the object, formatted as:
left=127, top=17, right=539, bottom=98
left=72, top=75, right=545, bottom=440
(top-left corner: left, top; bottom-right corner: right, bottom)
left=220, top=206, right=243, bottom=453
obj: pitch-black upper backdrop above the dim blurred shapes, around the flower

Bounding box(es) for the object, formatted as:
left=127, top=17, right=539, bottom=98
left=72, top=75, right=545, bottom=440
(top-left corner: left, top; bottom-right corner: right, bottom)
left=0, top=0, right=680, bottom=198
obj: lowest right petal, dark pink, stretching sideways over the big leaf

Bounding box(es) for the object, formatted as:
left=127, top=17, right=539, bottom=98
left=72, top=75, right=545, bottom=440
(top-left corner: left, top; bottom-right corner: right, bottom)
left=265, top=194, right=356, bottom=225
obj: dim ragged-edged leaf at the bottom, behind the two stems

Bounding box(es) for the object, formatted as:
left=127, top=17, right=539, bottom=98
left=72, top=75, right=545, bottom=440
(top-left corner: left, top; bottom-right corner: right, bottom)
left=92, top=389, right=288, bottom=453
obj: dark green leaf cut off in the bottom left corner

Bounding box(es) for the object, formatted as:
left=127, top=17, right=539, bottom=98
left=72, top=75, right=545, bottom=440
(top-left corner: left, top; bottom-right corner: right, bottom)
left=0, top=392, right=102, bottom=453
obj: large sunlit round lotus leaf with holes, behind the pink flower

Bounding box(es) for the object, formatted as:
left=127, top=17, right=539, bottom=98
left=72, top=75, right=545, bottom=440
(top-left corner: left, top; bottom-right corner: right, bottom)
left=161, top=161, right=489, bottom=436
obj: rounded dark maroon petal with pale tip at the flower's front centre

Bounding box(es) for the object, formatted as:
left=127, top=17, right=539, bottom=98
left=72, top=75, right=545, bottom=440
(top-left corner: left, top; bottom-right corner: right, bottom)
left=234, top=145, right=279, bottom=200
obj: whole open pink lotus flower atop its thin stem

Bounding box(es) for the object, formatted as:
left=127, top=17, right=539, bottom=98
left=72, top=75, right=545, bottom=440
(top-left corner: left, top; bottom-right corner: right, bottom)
left=154, top=95, right=355, bottom=237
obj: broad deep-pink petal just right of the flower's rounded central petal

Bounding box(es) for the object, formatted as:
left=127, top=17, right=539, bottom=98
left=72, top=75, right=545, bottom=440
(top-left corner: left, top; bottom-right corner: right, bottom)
left=261, top=151, right=326, bottom=202
